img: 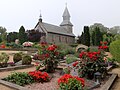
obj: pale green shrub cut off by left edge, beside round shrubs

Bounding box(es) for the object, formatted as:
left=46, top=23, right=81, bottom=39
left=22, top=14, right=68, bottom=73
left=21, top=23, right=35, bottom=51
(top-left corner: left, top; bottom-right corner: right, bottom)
left=0, top=53, right=9, bottom=67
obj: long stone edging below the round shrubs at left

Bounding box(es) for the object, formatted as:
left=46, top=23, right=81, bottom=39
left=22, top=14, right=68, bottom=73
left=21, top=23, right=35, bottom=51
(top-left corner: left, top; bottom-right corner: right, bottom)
left=0, top=64, right=34, bottom=72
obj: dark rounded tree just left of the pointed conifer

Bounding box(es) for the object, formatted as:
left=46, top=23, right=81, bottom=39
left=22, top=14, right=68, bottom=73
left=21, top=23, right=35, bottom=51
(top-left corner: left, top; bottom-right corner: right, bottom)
left=7, top=32, right=19, bottom=43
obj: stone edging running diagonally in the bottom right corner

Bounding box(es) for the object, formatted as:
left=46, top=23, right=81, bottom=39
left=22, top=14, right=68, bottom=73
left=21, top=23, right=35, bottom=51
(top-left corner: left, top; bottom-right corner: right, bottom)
left=101, top=73, right=118, bottom=90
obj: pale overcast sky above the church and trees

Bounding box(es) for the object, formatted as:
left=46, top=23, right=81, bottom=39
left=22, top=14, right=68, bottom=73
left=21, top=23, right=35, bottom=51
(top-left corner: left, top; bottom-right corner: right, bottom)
left=0, top=0, right=120, bottom=36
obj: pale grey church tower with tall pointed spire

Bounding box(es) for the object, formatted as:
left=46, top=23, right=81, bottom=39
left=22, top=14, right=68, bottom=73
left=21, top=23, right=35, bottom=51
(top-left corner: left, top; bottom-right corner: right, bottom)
left=60, top=6, right=73, bottom=33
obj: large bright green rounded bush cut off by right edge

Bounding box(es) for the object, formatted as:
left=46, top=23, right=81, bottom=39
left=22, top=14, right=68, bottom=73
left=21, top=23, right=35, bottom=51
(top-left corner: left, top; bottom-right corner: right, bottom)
left=109, top=40, right=120, bottom=62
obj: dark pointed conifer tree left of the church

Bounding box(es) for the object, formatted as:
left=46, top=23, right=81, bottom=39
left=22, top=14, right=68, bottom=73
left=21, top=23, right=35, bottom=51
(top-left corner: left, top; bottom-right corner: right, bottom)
left=19, top=26, right=27, bottom=44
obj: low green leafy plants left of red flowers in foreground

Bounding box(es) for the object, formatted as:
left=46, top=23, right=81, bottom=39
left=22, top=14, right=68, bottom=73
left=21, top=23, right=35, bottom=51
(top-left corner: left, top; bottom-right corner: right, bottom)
left=3, top=72, right=34, bottom=86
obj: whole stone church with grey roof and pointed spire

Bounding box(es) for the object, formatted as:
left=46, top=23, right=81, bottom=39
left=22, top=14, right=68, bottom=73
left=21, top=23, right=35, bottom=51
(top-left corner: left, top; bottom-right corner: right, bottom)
left=31, top=7, right=75, bottom=44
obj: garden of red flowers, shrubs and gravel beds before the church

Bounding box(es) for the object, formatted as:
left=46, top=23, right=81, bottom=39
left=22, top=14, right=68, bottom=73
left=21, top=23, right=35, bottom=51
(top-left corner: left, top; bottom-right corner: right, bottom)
left=0, top=39, right=118, bottom=90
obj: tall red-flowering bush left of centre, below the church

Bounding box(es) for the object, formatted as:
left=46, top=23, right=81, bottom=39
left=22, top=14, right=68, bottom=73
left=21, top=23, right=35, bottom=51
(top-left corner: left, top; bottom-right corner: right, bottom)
left=38, top=43, right=59, bottom=72
